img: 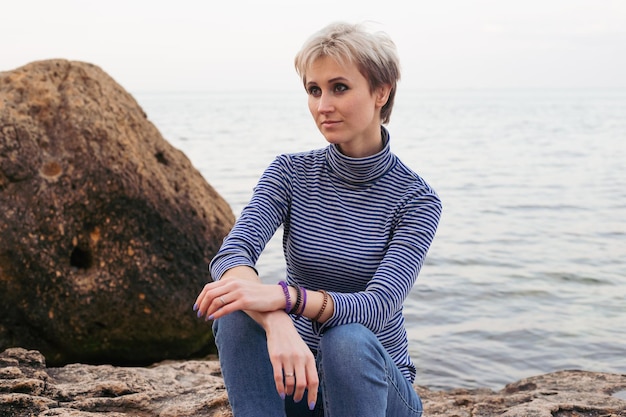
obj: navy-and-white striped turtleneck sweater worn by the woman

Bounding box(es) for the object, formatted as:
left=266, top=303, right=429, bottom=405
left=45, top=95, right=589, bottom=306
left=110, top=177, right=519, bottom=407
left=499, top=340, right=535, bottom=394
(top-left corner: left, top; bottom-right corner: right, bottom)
left=210, top=127, right=441, bottom=383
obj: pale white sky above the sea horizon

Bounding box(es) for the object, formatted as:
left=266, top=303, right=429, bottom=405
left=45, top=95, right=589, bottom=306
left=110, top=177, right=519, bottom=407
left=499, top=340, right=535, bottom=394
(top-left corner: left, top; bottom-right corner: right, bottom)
left=0, top=0, right=626, bottom=93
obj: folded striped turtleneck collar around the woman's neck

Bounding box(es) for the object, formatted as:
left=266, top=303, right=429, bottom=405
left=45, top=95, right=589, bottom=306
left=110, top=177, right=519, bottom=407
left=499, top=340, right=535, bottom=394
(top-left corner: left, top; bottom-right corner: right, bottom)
left=326, top=126, right=394, bottom=184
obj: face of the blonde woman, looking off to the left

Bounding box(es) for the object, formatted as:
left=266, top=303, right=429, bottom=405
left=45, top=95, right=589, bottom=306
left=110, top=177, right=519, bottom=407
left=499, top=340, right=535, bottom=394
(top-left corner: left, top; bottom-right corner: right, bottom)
left=305, top=57, right=390, bottom=158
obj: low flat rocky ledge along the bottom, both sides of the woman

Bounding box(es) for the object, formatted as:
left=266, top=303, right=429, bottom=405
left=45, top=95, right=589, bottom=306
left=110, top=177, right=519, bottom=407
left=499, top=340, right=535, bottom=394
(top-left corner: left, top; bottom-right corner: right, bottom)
left=0, top=348, right=626, bottom=417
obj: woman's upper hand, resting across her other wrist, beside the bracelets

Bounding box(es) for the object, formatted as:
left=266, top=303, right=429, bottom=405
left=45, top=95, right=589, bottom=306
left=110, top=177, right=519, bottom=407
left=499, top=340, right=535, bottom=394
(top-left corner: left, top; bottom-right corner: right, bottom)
left=194, top=279, right=285, bottom=320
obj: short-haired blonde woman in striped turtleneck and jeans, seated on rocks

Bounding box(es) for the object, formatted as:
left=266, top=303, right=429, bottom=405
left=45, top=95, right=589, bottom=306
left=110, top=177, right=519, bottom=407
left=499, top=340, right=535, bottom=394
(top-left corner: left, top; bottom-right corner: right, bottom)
left=194, top=23, right=441, bottom=417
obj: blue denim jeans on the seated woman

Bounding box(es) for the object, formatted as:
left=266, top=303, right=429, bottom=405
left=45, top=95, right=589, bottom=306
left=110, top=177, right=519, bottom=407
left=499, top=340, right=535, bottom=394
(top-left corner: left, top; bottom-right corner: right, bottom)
left=213, top=311, right=422, bottom=417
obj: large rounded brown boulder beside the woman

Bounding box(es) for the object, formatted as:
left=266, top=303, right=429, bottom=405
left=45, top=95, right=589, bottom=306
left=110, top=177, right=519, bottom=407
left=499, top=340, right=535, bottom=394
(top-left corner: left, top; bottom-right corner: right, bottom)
left=0, top=60, right=234, bottom=365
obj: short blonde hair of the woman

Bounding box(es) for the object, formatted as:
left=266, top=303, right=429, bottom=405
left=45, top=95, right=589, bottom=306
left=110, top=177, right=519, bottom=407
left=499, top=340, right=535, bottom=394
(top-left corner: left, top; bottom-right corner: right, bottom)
left=295, top=22, right=400, bottom=124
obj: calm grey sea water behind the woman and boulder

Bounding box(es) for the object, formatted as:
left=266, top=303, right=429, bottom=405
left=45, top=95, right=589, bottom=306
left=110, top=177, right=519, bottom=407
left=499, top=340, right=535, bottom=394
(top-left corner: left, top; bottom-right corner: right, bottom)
left=134, top=90, right=626, bottom=389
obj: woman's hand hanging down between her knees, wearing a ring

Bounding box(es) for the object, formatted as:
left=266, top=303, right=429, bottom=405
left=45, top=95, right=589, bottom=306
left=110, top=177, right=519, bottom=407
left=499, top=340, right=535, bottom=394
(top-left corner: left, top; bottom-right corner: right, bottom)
left=262, top=312, right=319, bottom=410
